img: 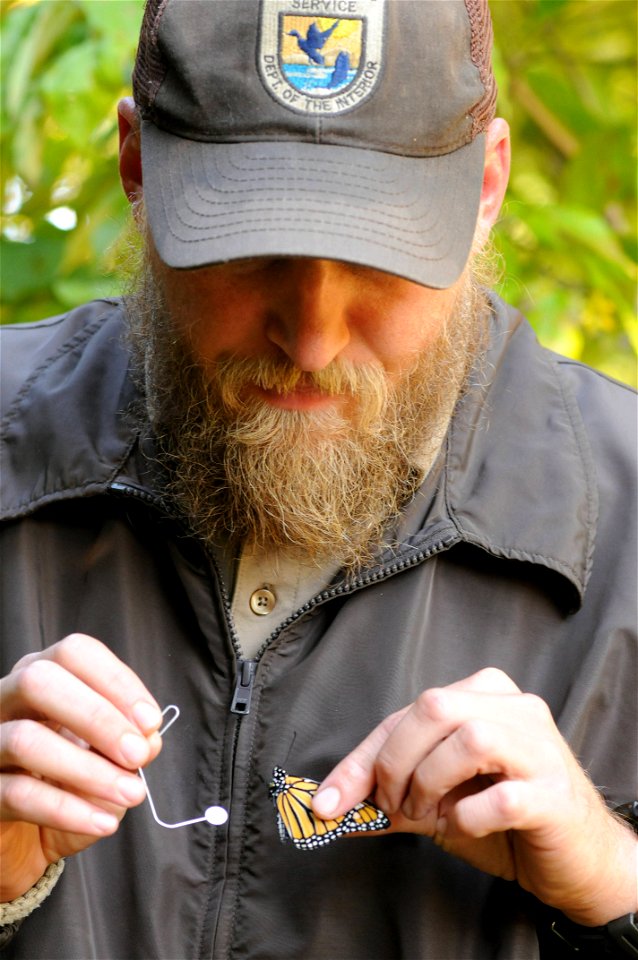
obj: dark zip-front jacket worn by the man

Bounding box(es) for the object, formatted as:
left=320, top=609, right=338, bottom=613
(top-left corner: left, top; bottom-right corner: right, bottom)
left=1, top=301, right=637, bottom=960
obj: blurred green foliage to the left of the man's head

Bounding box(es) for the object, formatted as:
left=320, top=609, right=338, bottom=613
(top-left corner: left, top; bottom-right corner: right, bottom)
left=0, top=0, right=143, bottom=323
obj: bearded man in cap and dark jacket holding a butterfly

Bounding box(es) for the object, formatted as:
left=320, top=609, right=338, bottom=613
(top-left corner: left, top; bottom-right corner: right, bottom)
left=0, top=0, right=638, bottom=960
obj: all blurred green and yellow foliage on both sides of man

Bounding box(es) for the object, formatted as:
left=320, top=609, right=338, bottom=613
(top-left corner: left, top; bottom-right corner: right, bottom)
left=0, top=0, right=638, bottom=384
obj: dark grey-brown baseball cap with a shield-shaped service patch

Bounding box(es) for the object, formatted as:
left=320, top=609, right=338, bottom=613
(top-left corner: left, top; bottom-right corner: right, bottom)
left=133, top=0, right=496, bottom=288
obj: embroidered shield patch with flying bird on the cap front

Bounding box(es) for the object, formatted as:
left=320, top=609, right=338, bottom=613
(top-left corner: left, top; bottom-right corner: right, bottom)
left=257, top=0, right=386, bottom=114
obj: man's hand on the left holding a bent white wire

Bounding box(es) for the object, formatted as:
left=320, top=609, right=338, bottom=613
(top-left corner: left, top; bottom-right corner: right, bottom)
left=0, top=634, right=162, bottom=902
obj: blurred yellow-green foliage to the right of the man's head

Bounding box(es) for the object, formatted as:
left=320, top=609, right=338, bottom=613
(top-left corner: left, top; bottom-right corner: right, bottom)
left=491, top=0, right=638, bottom=384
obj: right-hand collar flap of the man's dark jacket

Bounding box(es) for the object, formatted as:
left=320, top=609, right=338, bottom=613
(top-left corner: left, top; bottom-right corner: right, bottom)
left=400, top=296, right=598, bottom=607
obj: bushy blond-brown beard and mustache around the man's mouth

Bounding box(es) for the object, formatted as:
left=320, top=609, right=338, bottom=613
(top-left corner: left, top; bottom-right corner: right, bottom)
left=126, top=262, right=488, bottom=570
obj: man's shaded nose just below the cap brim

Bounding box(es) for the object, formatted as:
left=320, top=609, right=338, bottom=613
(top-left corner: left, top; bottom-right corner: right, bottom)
left=266, top=258, right=353, bottom=373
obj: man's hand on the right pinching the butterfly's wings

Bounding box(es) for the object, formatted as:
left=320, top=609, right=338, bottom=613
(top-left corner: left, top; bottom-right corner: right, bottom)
left=313, top=668, right=638, bottom=926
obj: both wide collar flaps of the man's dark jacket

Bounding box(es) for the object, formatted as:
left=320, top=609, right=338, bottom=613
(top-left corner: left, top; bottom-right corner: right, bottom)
left=0, top=297, right=597, bottom=599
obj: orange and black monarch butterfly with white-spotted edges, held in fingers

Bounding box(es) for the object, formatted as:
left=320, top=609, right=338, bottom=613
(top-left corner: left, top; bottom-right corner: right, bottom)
left=268, top=767, right=390, bottom=850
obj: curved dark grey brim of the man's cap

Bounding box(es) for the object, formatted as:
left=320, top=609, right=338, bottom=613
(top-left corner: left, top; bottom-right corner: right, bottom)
left=142, top=122, right=485, bottom=288
